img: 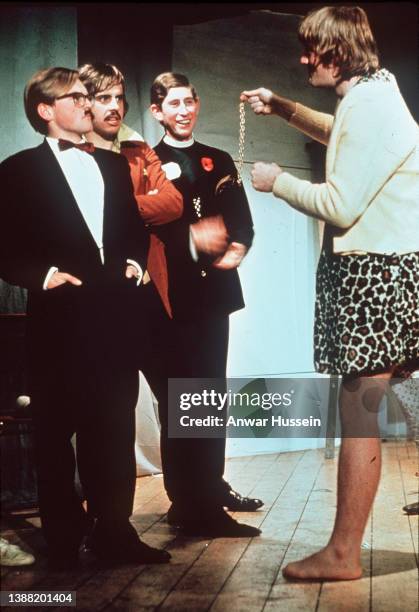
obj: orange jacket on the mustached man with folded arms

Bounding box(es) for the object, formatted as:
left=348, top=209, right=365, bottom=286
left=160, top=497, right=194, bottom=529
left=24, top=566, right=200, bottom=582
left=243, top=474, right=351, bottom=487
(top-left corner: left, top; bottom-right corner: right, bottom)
left=121, top=140, right=183, bottom=317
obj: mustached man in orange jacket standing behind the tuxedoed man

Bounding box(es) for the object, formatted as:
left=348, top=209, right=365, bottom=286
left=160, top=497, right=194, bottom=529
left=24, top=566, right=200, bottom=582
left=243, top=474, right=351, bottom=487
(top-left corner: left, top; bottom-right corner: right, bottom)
left=79, top=62, right=183, bottom=468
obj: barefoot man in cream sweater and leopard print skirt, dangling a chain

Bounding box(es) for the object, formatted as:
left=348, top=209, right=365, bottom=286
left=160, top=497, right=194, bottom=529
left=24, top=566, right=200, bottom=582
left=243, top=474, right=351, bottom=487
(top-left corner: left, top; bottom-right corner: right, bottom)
left=241, top=6, right=419, bottom=580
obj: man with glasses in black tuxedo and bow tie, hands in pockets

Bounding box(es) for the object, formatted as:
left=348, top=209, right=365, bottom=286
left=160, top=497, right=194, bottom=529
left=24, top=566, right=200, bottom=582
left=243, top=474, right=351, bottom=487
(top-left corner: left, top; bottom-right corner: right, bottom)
left=0, top=68, right=170, bottom=569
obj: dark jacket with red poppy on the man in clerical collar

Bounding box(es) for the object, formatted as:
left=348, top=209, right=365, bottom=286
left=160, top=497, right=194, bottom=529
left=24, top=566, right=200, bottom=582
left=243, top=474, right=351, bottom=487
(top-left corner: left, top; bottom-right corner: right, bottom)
left=155, top=141, right=254, bottom=319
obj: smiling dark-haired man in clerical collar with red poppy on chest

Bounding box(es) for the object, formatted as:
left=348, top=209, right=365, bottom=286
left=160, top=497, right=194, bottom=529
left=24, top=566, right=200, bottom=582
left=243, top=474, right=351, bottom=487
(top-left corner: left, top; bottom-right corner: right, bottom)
left=151, top=73, right=263, bottom=537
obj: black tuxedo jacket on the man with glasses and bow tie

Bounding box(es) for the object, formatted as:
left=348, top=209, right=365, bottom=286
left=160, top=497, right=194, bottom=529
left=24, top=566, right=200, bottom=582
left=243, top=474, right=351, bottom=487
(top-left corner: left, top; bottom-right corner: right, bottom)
left=0, top=141, right=149, bottom=380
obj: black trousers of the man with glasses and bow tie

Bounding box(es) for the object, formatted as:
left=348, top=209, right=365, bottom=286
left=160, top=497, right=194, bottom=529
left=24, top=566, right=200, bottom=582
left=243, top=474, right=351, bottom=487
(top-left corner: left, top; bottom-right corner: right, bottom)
left=31, top=362, right=138, bottom=555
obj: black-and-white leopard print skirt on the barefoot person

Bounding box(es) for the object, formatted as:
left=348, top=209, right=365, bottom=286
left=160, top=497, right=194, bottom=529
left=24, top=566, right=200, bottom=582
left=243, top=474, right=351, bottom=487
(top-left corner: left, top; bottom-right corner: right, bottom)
left=314, top=250, right=419, bottom=376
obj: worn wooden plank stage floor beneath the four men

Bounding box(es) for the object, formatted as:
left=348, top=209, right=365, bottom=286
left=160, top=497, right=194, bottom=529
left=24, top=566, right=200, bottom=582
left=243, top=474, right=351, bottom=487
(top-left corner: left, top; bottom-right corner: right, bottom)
left=1, top=442, right=419, bottom=612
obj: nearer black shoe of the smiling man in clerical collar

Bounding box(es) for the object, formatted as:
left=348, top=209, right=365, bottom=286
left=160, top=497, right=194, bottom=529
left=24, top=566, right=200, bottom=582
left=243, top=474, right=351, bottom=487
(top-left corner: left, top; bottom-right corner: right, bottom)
left=180, top=509, right=261, bottom=538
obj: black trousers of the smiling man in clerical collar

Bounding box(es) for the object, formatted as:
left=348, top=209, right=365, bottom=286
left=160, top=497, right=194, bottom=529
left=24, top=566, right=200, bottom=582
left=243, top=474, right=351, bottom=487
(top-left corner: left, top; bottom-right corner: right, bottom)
left=154, top=316, right=230, bottom=507
